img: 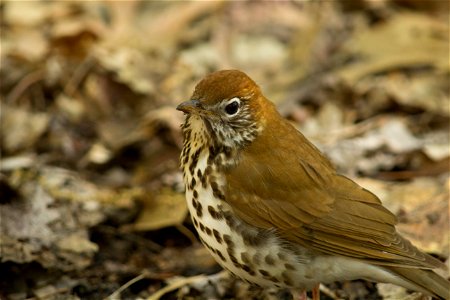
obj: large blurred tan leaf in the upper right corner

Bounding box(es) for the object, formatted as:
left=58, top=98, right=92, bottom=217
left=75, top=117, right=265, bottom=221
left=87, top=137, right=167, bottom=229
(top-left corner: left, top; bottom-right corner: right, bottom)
left=338, top=13, right=450, bottom=85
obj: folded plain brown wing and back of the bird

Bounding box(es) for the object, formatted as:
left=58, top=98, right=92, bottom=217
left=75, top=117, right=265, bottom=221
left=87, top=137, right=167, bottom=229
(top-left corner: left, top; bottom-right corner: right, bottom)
left=225, top=116, right=442, bottom=268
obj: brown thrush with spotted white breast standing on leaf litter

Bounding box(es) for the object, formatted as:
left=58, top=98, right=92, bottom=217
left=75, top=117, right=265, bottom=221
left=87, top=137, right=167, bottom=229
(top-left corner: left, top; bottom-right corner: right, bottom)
left=177, top=70, right=450, bottom=299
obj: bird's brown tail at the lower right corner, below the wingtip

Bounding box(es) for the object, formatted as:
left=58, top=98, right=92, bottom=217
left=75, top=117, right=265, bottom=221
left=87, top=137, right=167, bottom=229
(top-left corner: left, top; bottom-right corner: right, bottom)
left=389, top=266, right=450, bottom=300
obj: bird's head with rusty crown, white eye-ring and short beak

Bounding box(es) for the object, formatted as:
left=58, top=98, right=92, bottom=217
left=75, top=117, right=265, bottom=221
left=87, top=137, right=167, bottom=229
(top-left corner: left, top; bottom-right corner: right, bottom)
left=177, top=70, right=267, bottom=148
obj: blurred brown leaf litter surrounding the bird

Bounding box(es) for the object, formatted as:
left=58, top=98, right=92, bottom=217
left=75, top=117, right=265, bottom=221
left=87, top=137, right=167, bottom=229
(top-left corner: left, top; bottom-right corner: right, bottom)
left=0, top=0, right=450, bottom=299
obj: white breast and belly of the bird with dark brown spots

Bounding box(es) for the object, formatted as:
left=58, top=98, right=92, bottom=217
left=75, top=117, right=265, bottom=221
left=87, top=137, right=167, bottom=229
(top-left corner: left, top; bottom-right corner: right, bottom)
left=181, top=116, right=398, bottom=289
